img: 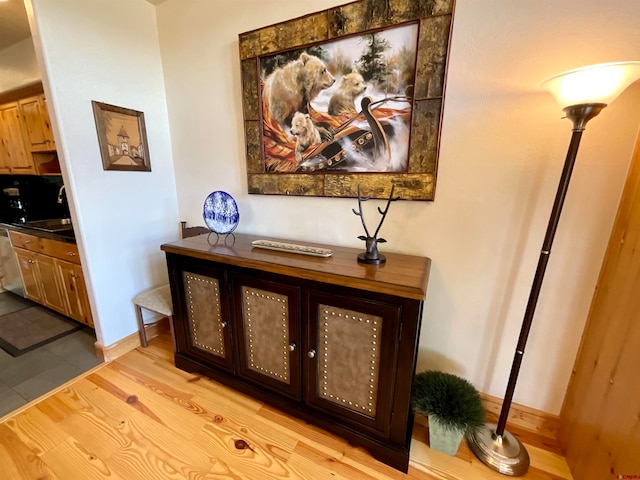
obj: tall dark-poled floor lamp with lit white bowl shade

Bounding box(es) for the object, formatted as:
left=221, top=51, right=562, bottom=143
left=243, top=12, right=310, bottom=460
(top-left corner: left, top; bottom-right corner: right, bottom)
left=467, top=61, right=640, bottom=477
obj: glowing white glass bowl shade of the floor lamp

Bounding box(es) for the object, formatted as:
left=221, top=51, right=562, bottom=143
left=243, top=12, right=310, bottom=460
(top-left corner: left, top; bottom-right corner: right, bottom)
left=542, top=61, right=640, bottom=108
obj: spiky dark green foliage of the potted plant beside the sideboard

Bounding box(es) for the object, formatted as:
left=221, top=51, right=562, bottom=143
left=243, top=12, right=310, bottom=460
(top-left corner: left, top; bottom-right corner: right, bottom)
left=411, top=370, right=484, bottom=429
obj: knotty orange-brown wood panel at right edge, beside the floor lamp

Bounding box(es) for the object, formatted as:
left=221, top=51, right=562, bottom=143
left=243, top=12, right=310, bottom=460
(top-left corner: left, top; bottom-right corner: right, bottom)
left=558, top=135, right=640, bottom=480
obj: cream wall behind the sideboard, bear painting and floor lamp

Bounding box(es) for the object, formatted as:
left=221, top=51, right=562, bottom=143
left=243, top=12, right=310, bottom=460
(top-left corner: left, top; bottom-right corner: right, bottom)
left=157, top=0, right=640, bottom=413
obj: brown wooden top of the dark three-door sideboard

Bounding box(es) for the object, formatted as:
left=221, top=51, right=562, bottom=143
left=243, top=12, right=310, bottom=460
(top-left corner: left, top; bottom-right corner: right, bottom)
left=161, top=234, right=431, bottom=300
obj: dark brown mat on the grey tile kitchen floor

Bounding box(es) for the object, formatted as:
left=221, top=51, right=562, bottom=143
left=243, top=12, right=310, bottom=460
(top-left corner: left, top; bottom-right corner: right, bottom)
left=0, top=307, right=84, bottom=357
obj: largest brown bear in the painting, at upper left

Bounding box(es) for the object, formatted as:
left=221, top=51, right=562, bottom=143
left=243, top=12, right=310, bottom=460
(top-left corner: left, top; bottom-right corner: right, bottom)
left=262, top=53, right=336, bottom=127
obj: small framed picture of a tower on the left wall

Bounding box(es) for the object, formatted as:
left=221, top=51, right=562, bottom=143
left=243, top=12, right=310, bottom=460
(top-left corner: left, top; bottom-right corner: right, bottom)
left=91, top=100, right=151, bottom=172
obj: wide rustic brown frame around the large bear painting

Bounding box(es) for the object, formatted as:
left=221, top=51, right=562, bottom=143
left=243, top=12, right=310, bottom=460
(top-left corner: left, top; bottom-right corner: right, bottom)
left=239, top=0, right=454, bottom=200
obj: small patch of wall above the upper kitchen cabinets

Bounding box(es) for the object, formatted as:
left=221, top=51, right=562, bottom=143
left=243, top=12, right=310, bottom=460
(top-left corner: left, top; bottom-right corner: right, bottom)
left=0, top=37, right=40, bottom=93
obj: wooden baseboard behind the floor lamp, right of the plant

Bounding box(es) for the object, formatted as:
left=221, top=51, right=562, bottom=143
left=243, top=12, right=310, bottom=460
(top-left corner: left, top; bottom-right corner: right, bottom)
left=480, top=393, right=560, bottom=439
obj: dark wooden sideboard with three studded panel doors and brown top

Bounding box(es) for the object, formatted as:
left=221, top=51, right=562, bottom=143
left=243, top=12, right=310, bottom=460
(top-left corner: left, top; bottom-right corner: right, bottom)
left=161, top=234, right=430, bottom=472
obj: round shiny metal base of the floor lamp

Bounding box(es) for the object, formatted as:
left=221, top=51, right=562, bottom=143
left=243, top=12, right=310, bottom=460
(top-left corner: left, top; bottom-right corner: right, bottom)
left=467, top=423, right=529, bottom=477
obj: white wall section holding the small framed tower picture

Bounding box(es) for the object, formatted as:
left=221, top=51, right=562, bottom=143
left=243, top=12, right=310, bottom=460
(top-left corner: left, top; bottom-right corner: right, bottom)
left=27, top=0, right=178, bottom=345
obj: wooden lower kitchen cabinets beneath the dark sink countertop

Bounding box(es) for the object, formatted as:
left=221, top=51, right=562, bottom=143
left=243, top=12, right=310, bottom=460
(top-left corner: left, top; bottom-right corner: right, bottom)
left=9, top=230, right=94, bottom=327
